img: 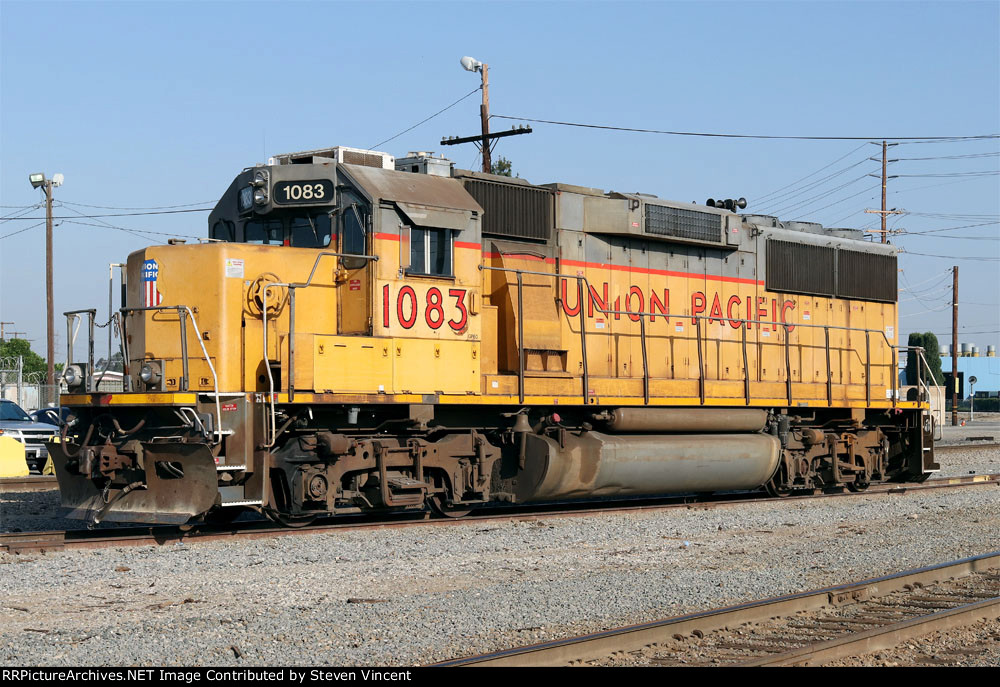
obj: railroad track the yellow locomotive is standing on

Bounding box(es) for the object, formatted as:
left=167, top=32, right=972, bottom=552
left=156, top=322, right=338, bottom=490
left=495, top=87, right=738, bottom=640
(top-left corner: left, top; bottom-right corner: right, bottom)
left=0, top=474, right=1000, bottom=553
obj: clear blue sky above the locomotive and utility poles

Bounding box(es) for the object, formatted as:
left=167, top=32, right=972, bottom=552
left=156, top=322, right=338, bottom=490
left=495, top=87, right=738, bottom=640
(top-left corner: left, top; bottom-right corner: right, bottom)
left=0, top=0, right=1000, bottom=360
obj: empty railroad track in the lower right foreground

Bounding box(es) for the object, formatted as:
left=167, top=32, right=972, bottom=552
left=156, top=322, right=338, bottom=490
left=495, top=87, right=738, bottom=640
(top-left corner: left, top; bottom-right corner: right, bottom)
left=439, top=551, right=1000, bottom=666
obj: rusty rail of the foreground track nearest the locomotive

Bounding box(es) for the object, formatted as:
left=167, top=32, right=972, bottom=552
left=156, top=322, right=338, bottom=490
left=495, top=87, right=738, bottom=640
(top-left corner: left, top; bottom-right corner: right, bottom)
left=437, top=551, right=1000, bottom=667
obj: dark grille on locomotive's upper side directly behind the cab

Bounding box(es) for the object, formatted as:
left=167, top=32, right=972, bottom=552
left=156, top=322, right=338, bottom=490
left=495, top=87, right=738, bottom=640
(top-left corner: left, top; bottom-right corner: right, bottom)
left=464, top=179, right=553, bottom=241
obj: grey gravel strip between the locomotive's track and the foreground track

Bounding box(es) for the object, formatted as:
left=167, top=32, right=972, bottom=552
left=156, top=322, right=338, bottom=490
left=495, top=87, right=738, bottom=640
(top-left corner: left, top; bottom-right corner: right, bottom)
left=0, top=476, right=1000, bottom=665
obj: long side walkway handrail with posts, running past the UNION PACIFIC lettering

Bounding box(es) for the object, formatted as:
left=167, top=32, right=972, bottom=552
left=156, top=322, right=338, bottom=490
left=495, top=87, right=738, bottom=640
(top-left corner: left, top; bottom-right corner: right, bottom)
left=479, top=265, right=897, bottom=407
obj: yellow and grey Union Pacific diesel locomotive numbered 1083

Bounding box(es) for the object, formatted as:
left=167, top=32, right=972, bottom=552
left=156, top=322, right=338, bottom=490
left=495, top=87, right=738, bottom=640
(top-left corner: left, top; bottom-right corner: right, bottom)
left=49, top=147, right=937, bottom=524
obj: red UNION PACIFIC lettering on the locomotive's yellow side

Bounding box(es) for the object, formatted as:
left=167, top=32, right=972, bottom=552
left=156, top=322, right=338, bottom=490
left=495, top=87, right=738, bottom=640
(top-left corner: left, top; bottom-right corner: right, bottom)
left=559, top=279, right=795, bottom=331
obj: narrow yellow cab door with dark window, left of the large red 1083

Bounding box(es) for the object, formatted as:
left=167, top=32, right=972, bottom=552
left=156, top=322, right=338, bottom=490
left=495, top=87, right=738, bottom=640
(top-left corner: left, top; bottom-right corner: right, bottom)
left=337, top=190, right=374, bottom=336
